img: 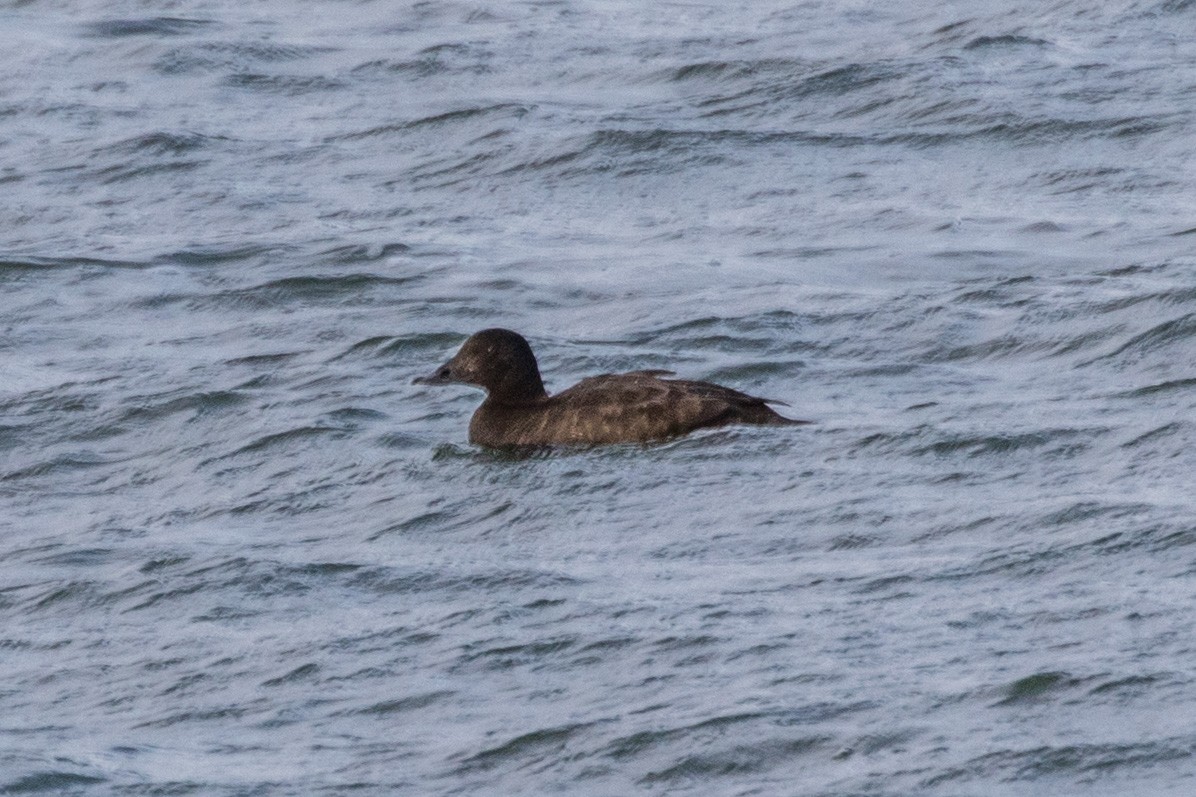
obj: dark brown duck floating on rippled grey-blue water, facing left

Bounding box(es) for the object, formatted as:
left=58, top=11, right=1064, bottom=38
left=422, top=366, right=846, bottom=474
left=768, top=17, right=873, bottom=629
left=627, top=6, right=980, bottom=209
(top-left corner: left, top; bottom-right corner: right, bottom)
left=415, top=329, right=808, bottom=448
